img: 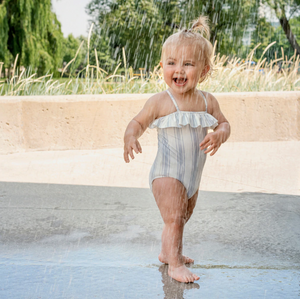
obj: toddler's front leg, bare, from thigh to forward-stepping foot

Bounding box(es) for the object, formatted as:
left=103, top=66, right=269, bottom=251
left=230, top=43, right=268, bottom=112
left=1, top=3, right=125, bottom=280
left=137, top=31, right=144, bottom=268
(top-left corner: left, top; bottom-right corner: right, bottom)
left=152, top=178, right=199, bottom=282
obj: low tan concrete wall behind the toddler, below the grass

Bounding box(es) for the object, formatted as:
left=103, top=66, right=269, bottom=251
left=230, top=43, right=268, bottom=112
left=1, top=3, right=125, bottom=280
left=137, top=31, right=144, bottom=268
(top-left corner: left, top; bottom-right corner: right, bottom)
left=0, top=92, right=300, bottom=153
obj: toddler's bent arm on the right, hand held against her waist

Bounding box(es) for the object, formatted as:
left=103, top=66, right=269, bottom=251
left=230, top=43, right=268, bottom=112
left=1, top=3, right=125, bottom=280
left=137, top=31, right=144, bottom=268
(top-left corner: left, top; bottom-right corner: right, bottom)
left=200, top=94, right=230, bottom=156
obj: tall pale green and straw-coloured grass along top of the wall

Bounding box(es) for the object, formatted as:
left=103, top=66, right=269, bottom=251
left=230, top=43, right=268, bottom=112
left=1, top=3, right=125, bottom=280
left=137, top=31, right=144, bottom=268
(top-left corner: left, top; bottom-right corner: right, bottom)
left=0, top=39, right=300, bottom=96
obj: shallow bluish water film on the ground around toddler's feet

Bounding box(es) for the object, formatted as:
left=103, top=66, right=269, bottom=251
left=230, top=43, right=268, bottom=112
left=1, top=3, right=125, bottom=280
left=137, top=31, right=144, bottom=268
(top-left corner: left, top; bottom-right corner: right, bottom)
left=0, top=244, right=300, bottom=299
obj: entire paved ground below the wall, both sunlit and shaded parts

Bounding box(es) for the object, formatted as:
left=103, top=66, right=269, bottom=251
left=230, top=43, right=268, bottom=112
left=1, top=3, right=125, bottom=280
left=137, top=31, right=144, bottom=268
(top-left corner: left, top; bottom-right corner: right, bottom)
left=0, top=142, right=300, bottom=299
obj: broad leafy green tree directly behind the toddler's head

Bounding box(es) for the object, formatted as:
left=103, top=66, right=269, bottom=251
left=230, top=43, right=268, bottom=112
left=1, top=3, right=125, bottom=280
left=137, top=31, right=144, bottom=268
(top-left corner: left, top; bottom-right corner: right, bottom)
left=87, top=0, right=259, bottom=68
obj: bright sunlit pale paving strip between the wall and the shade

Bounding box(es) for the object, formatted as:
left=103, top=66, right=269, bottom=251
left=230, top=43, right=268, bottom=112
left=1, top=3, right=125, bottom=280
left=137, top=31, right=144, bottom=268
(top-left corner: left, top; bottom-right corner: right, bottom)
left=0, top=141, right=300, bottom=195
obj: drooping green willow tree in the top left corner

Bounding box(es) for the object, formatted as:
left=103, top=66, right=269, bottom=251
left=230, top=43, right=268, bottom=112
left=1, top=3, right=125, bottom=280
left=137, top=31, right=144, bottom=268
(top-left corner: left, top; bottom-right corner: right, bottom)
left=0, top=0, right=63, bottom=74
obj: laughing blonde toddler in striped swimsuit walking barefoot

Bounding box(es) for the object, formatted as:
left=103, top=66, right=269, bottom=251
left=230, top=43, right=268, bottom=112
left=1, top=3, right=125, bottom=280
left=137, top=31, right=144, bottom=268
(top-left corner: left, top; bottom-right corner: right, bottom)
left=124, top=16, right=230, bottom=283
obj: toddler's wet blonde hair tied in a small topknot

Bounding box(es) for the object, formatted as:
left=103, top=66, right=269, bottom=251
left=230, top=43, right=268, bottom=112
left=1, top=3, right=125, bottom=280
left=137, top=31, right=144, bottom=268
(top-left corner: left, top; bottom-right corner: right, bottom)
left=161, top=16, right=214, bottom=83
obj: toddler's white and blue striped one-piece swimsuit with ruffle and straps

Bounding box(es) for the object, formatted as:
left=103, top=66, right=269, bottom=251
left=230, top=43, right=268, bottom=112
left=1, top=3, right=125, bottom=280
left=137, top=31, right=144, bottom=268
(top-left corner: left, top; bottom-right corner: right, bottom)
left=149, top=90, right=218, bottom=198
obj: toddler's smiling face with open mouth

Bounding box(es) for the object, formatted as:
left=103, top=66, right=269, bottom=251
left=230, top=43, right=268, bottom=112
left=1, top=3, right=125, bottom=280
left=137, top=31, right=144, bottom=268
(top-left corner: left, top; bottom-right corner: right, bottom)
left=160, top=45, right=206, bottom=94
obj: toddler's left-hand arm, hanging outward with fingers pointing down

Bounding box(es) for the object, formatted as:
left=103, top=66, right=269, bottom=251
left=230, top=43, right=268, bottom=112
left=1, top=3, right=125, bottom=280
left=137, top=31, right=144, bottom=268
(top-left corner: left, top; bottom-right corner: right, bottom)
left=124, top=96, right=158, bottom=163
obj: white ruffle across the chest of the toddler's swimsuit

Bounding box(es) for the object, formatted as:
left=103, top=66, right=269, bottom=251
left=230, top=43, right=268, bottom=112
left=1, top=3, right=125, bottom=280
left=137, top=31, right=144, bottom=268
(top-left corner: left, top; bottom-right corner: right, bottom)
left=149, top=111, right=218, bottom=129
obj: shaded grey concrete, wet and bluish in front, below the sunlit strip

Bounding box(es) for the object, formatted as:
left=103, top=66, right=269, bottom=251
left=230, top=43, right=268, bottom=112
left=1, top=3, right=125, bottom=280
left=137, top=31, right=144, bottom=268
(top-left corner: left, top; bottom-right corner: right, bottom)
left=0, top=182, right=300, bottom=299
